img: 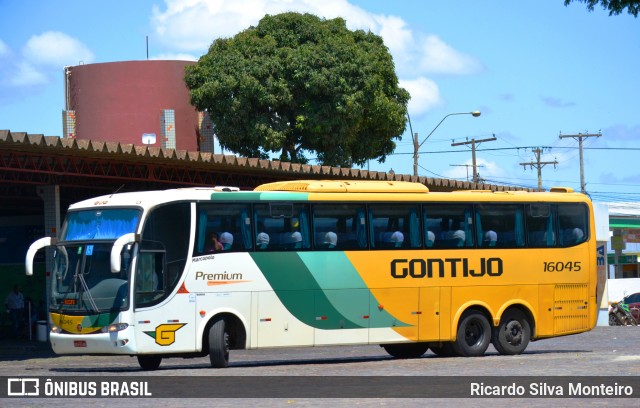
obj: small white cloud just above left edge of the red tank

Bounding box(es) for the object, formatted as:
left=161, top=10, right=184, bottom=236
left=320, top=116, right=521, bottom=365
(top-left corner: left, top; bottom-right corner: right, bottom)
left=23, top=31, right=94, bottom=68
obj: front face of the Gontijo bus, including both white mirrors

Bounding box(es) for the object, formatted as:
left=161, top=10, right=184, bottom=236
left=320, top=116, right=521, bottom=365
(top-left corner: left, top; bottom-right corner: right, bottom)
left=26, top=208, right=142, bottom=354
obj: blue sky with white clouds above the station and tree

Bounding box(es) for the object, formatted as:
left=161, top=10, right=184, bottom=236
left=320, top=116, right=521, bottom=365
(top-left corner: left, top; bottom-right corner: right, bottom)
left=0, top=0, right=640, bottom=201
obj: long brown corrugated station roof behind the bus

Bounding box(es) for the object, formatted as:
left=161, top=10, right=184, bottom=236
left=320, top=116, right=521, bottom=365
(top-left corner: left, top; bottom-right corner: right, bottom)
left=0, top=130, right=522, bottom=214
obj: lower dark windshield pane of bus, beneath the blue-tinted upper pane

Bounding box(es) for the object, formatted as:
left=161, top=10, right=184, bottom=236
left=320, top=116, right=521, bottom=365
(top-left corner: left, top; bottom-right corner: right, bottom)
left=49, top=242, right=131, bottom=315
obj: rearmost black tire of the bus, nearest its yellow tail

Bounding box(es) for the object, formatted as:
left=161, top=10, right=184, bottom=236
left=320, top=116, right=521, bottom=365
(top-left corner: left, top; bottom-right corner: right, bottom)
left=491, top=309, right=531, bottom=356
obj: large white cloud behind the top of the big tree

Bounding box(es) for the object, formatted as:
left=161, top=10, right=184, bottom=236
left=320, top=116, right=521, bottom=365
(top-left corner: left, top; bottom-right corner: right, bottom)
left=151, top=0, right=482, bottom=117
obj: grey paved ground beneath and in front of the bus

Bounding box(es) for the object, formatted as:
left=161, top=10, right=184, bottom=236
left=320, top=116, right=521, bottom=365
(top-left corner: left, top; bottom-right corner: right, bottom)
left=0, top=327, right=640, bottom=408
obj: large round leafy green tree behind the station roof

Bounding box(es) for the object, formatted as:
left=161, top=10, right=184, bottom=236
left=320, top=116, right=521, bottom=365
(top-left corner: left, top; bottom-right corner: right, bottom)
left=185, top=13, right=409, bottom=167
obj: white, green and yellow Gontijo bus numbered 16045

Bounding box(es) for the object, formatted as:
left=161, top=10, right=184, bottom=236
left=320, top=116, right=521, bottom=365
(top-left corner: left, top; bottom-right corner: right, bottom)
left=26, top=180, right=597, bottom=370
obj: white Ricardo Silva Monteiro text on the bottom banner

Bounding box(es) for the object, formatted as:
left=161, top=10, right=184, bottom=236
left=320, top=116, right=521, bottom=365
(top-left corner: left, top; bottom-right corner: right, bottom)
left=471, top=382, right=633, bottom=397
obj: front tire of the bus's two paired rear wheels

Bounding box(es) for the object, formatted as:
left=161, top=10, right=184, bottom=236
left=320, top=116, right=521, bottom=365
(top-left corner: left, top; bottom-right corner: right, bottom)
left=453, top=310, right=491, bottom=357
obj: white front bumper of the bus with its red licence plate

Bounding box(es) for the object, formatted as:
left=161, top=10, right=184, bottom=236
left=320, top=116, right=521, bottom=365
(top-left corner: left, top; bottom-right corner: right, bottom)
left=49, top=326, right=136, bottom=354
